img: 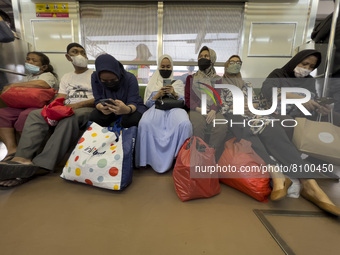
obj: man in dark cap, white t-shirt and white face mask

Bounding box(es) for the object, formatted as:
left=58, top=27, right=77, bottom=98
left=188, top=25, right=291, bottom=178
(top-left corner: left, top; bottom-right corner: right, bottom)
left=0, top=43, right=94, bottom=188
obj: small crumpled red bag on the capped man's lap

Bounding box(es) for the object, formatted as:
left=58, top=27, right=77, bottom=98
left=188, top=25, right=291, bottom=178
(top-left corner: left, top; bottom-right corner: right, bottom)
left=41, top=97, right=74, bottom=126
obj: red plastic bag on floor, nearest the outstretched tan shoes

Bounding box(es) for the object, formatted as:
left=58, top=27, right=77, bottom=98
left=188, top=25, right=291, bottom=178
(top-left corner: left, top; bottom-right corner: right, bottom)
left=218, top=138, right=271, bottom=202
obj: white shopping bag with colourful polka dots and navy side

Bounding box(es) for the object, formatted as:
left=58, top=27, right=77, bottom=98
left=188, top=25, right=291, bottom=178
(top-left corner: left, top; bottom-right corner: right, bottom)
left=61, top=123, right=137, bottom=190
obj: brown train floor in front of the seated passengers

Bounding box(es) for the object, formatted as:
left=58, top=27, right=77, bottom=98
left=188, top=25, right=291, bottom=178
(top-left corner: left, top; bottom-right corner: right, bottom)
left=0, top=162, right=340, bottom=255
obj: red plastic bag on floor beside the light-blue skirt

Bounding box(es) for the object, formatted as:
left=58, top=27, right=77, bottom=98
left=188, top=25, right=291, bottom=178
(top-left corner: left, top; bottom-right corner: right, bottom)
left=173, top=137, right=221, bottom=202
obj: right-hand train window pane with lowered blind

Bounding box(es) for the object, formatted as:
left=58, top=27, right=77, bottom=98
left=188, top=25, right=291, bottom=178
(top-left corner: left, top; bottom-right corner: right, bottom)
left=163, top=2, right=243, bottom=62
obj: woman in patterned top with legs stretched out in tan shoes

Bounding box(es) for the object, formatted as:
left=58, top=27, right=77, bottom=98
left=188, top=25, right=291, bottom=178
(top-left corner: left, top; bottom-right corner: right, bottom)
left=221, top=55, right=340, bottom=216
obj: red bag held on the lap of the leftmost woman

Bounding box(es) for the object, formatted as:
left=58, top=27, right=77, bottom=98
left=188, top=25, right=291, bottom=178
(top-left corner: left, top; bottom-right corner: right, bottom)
left=0, top=87, right=56, bottom=109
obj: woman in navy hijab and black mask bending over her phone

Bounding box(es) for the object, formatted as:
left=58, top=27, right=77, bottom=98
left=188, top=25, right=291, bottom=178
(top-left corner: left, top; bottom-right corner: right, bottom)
left=90, top=54, right=147, bottom=128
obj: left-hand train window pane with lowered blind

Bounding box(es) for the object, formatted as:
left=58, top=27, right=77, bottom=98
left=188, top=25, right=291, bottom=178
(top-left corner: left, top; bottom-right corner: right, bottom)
left=80, top=2, right=157, bottom=61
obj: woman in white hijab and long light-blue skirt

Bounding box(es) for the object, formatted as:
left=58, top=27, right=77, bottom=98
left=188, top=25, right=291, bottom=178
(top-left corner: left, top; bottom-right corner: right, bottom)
left=136, top=55, right=192, bottom=173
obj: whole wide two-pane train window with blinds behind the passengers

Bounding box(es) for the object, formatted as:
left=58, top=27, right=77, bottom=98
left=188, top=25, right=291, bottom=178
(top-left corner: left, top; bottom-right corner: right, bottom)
left=80, top=1, right=244, bottom=84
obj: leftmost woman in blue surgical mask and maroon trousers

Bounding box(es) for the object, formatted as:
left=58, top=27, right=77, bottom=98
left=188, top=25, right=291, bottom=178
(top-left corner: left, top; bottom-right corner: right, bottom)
left=0, top=52, right=58, bottom=160
